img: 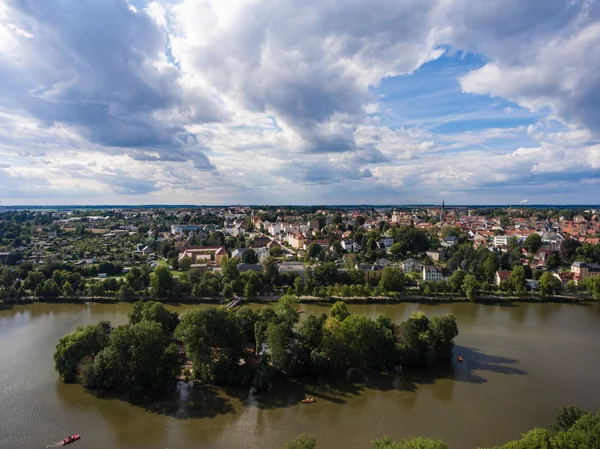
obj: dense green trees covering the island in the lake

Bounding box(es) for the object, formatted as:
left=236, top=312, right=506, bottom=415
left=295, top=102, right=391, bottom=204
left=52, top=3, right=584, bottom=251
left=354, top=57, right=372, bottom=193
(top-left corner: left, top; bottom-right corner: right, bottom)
left=54, top=296, right=458, bottom=389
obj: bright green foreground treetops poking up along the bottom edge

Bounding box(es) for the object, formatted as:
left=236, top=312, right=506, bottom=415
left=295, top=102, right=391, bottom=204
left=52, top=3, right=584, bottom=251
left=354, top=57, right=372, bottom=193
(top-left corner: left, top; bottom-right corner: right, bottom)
left=285, top=406, right=600, bottom=449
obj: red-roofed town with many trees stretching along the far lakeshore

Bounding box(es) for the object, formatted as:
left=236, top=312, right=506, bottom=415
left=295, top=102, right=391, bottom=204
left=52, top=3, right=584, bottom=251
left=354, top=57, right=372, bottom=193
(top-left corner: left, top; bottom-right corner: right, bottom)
left=0, top=202, right=600, bottom=301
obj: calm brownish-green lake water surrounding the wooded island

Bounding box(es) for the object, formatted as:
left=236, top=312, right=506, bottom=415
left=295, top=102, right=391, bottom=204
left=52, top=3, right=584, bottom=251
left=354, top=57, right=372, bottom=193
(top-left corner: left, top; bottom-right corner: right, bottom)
left=0, top=303, right=600, bottom=449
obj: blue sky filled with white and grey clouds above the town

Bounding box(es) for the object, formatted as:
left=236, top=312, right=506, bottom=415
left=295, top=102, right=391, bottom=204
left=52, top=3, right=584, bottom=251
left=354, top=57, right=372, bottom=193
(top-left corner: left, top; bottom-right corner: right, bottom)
left=0, top=0, right=600, bottom=205
